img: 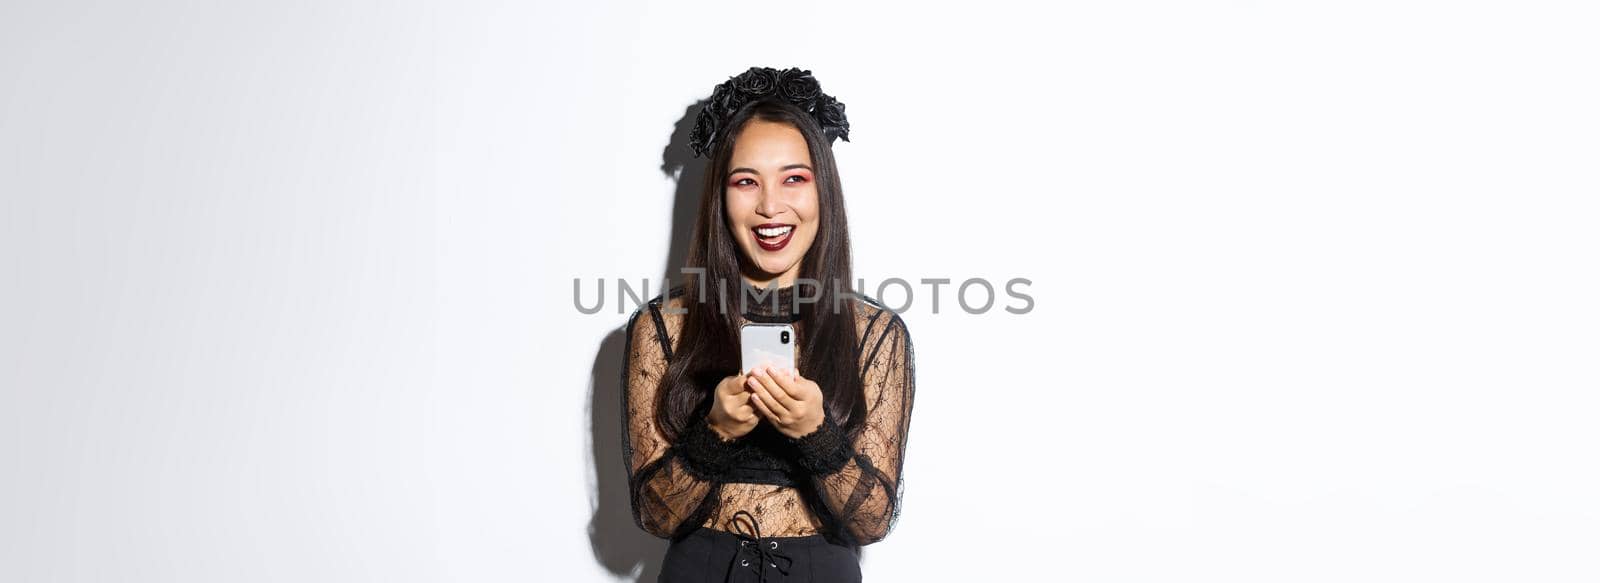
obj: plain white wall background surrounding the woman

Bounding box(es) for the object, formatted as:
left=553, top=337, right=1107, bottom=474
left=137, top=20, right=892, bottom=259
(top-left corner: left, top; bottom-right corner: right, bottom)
left=0, top=0, right=1600, bottom=581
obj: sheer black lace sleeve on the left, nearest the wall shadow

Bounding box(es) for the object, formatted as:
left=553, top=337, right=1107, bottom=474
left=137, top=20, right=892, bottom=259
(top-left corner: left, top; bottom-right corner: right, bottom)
left=622, top=303, right=731, bottom=538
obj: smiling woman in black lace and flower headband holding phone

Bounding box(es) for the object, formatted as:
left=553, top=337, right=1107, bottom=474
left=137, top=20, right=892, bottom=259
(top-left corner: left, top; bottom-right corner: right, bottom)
left=622, top=67, right=914, bottom=581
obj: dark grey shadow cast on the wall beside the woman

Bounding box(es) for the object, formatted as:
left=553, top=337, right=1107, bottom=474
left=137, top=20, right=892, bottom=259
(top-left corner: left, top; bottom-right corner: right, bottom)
left=589, top=103, right=706, bottom=581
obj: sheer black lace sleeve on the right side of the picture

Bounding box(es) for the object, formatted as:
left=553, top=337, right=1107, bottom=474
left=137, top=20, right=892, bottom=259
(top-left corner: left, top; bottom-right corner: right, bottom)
left=794, top=312, right=915, bottom=545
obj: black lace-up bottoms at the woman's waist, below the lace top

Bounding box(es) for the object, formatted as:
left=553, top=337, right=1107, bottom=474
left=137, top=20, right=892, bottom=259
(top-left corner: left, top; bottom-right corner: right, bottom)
left=658, top=512, right=861, bottom=583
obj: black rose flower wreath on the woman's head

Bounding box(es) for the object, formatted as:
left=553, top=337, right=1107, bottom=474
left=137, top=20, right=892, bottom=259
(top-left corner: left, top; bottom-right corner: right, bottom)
left=690, top=67, right=850, bottom=157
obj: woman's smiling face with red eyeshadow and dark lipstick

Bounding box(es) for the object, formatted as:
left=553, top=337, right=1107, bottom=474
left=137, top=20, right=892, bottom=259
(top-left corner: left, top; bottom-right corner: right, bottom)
left=723, top=120, right=818, bottom=287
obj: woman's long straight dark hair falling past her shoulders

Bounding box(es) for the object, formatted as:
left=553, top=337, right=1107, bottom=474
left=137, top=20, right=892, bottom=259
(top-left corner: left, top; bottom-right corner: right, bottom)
left=656, top=99, right=866, bottom=439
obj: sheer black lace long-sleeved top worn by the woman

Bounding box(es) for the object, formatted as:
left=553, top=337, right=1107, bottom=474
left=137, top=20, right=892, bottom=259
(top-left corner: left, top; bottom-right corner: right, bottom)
left=622, top=287, right=914, bottom=546
